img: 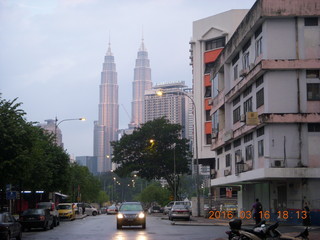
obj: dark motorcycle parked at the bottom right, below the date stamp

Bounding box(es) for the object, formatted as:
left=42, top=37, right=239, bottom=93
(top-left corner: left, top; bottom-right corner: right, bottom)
left=226, top=219, right=309, bottom=240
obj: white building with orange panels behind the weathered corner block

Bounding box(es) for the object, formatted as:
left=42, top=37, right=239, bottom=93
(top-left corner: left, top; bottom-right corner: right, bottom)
left=190, top=9, right=248, bottom=178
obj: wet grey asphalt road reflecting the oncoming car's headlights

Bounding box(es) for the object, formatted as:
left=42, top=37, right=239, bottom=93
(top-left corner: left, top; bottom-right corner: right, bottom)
left=22, top=214, right=228, bottom=240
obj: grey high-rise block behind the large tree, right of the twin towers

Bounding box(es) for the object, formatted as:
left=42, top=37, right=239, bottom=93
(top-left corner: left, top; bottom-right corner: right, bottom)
left=144, top=81, right=193, bottom=139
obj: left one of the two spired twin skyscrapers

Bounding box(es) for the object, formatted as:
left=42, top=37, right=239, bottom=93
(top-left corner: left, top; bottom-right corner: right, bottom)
left=93, top=43, right=119, bottom=172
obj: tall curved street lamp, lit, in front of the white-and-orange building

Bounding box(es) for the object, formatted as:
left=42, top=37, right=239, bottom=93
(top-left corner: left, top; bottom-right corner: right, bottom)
left=156, top=89, right=200, bottom=217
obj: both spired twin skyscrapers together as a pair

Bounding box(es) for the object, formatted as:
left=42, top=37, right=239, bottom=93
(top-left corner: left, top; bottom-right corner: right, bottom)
left=93, top=39, right=152, bottom=173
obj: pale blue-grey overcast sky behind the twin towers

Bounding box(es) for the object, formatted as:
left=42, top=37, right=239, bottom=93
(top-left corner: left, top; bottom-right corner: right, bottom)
left=0, top=0, right=255, bottom=157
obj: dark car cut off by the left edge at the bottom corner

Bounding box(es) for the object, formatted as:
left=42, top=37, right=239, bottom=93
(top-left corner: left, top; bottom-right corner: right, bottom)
left=0, top=212, right=22, bottom=240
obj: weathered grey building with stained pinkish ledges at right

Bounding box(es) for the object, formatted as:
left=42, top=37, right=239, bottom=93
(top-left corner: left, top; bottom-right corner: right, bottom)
left=210, top=0, right=320, bottom=224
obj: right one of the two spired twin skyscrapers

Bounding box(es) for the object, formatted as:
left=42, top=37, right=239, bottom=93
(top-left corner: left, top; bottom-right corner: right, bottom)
left=130, top=39, right=152, bottom=127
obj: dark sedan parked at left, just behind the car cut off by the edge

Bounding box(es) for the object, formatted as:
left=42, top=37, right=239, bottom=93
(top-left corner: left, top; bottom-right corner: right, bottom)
left=19, top=208, right=53, bottom=230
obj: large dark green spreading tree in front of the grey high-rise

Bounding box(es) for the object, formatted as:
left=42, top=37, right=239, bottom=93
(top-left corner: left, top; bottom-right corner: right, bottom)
left=111, top=118, right=191, bottom=199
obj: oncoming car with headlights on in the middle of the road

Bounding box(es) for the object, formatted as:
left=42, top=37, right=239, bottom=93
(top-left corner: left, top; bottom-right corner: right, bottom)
left=117, top=202, right=146, bottom=229
